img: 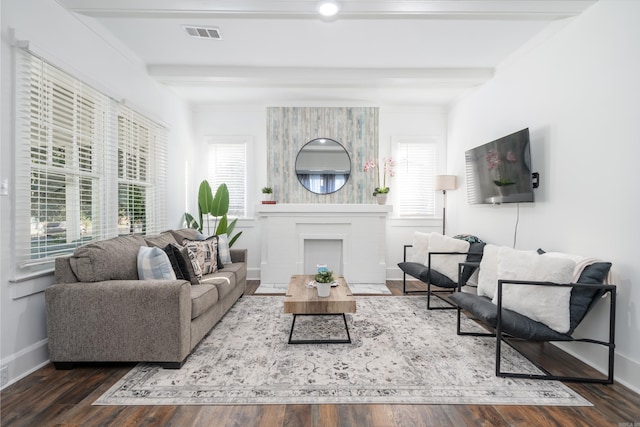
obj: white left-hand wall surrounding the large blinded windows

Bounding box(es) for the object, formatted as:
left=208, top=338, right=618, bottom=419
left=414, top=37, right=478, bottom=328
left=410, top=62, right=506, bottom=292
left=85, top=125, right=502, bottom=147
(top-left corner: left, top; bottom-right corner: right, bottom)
left=0, top=0, right=192, bottom=390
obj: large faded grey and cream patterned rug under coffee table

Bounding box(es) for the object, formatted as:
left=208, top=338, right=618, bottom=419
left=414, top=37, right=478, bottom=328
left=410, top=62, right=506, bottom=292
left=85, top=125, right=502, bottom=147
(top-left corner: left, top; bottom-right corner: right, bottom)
left=94, top=296, right=591, bottom=406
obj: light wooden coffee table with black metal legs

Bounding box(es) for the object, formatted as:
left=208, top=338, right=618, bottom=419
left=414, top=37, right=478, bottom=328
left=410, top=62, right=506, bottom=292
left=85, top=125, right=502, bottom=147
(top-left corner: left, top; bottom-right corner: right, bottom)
left=284, top=274, right=356, bottom=344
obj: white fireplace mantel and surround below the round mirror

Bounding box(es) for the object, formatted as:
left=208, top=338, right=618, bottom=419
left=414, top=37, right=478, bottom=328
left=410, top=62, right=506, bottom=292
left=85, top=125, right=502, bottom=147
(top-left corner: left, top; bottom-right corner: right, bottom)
left=256, top=203, right=392, bottom=284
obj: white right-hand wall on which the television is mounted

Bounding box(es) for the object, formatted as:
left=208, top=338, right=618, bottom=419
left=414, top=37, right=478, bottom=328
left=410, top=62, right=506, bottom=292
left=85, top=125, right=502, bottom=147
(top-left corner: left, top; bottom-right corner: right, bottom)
left=448, top=0, right=640, bottom=390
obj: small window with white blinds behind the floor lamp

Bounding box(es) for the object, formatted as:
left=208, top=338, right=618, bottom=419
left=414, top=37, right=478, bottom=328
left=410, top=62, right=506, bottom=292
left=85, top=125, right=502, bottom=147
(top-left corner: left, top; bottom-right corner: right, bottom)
left=395, top=138, right=437, bottom=216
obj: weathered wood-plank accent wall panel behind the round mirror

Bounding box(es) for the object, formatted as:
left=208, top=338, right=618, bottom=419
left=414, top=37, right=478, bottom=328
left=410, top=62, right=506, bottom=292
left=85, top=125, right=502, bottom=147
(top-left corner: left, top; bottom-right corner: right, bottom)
left=267, top=107, right=379, bottom=203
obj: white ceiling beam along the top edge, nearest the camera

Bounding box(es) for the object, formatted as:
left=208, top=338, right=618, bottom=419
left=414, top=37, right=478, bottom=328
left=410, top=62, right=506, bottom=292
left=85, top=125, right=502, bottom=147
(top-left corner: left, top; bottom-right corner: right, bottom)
left=57, top=0, right=597, bottom=19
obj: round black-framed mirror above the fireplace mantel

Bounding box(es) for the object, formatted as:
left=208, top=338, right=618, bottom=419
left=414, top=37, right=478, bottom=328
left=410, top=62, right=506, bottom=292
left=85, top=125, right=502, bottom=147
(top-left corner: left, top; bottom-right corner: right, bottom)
left=296, top=138, right=351, bottom=194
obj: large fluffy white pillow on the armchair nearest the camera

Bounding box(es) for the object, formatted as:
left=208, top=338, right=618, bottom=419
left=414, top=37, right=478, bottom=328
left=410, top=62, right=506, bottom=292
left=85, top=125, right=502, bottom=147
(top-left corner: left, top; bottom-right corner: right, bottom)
left=493, top=247, right=576, bottom=333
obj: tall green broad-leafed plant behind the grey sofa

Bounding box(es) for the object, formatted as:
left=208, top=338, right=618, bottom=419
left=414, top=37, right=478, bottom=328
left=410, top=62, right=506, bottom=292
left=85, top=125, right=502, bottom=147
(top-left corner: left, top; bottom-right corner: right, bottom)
left=184, top=179, right=242, bottom=247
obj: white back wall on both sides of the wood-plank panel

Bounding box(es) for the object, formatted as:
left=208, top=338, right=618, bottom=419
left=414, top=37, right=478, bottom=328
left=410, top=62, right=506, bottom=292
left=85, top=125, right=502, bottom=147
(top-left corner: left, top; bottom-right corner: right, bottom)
left=191, top=105, right=447, bottom=279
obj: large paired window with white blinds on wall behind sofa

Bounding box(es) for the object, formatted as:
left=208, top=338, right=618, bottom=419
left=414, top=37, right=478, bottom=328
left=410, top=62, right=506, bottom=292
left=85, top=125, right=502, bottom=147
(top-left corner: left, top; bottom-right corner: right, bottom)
left=15, top=49, right=166, bottom=268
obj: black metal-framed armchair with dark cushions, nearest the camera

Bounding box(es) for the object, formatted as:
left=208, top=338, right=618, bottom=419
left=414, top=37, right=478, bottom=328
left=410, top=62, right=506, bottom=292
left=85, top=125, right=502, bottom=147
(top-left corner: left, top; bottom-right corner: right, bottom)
left=456, top=280, right=616, bottom=384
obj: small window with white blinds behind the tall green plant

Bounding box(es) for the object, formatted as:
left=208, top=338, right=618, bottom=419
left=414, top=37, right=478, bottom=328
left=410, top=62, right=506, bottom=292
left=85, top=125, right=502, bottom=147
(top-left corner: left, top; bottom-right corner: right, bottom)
left=207, top=136, right=249, bottom=218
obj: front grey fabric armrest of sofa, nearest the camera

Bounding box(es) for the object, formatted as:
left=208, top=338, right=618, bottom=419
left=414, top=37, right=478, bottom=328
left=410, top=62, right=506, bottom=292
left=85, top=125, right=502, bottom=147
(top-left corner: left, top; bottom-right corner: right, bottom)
left=45, top=280, right=191, bottom=362
